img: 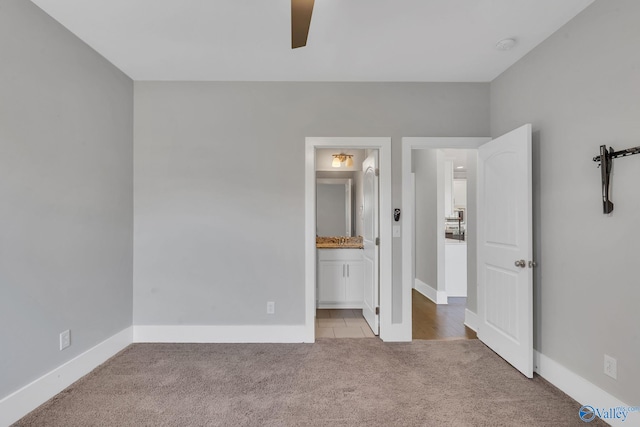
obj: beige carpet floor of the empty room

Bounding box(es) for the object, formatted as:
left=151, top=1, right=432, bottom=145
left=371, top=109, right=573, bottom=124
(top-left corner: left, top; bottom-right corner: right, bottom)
left=16, top=338, right=606, bottom=427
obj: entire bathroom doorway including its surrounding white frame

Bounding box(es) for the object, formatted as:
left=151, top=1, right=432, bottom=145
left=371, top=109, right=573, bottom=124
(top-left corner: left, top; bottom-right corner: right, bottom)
left=305, top=138, right=391, bottom=339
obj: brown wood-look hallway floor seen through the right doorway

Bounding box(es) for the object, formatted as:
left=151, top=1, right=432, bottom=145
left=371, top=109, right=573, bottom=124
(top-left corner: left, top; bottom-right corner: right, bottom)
left=412, top=289, right=477, bottom=340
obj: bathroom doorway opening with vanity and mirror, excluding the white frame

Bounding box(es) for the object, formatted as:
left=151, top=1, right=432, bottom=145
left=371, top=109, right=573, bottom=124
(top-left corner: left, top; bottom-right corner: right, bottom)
left=315, top=147, right=379, bottom=338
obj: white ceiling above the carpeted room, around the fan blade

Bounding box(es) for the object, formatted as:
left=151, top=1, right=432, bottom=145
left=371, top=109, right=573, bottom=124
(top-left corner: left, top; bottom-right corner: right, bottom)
left=32, top=0, right=593, bottom=82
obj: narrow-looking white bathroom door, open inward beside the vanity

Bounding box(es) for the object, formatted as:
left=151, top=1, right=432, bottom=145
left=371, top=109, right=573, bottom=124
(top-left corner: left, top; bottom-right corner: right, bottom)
left=362, top=151, right=379, bottom=335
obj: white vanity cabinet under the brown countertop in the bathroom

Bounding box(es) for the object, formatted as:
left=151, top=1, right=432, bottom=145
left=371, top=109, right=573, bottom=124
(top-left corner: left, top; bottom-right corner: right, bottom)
left=316, top=249, right=364, bottom=308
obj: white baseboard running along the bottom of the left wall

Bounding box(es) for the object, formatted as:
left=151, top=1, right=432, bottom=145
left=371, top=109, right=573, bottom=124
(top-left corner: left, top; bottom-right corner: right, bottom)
left=0, top=327, right=133, bottom=426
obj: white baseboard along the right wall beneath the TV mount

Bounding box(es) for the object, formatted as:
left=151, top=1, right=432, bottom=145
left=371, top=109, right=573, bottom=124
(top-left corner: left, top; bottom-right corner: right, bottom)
left=533, top=350, right=640, bottom=426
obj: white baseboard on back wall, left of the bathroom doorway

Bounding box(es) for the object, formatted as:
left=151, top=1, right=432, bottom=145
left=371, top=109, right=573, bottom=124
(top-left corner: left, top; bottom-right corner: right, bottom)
left=133, top=325, right=310, bottom=343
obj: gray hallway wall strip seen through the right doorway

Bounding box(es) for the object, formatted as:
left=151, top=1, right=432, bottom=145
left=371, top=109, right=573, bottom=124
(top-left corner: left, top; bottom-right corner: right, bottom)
left=411, top=149, right=442, bottom=290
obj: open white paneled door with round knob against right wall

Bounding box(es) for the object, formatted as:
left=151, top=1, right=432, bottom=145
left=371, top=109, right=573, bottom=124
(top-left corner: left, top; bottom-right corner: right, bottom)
left=478, top=124, right=534, bottom=378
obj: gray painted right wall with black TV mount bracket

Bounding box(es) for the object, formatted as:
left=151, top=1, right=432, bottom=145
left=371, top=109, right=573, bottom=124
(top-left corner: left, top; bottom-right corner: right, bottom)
left=491, top=0, right=640, bottom=405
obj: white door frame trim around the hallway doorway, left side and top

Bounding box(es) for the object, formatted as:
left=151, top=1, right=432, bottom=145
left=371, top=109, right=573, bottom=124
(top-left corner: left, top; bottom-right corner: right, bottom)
left=402, top=137, right=491, bottom=341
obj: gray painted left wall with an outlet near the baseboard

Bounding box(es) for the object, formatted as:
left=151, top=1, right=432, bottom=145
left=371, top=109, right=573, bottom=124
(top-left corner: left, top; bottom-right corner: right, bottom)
left=0, top=0, right=133, bottom=399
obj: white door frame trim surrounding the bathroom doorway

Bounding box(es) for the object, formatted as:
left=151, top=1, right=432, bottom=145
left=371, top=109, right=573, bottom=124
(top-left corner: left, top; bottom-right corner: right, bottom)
left=305, top=137, right=394, bottom=342
